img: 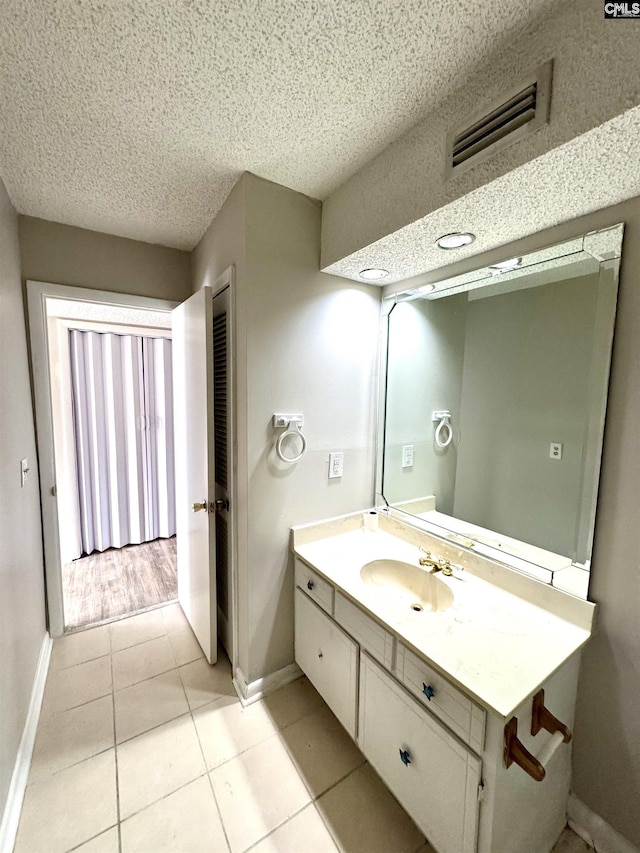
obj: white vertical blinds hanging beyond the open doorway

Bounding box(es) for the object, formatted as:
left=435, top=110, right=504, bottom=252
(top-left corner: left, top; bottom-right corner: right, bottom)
left=69, top=330, right=175, bottom=554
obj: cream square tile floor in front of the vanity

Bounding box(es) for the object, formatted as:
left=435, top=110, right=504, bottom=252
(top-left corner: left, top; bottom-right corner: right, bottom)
left=15, top=605, right=588, bottom=853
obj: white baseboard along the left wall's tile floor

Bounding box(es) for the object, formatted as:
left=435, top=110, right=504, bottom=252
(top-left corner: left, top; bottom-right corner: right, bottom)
left=0, top=634, right=53, bottom=853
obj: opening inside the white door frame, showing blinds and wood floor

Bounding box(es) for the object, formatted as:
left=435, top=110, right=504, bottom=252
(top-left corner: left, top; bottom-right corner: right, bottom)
left=62, top=322, right=177, bottom=630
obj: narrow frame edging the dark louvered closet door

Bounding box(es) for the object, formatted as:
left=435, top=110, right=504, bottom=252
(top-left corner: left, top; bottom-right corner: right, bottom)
left=209, top=264, right=238, bottom=671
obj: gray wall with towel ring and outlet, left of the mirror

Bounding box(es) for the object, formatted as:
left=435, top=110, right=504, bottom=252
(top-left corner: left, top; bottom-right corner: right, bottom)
left=193, top=174, right=380, bottom=681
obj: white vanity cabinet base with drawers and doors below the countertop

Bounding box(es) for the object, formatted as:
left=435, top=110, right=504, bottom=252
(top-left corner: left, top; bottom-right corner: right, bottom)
left=295, top=556, right=580, bottom=853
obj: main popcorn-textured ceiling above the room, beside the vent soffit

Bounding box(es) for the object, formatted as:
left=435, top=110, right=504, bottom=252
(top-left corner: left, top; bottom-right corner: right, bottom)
left=0, top=0, right=561, bottom=249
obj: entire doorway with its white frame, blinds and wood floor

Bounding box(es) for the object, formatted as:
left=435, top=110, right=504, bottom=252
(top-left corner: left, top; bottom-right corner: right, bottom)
left=28, top=282, right=177, bottom=636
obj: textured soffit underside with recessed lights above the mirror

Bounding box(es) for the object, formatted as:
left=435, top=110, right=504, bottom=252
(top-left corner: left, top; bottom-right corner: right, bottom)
left=324, top=107, right=640, bottom=286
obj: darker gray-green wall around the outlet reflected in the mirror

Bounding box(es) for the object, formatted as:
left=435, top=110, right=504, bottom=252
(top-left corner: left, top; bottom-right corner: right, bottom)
left=454, top=274, right=598, bottom=559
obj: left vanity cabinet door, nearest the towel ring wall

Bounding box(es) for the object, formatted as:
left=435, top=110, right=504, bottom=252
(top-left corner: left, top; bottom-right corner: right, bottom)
left=295, top=589, right=358, bottom=740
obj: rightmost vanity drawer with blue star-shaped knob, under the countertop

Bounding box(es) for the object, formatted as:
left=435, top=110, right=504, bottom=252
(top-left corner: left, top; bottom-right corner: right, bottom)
left=396, top=643, right=487, bottom=753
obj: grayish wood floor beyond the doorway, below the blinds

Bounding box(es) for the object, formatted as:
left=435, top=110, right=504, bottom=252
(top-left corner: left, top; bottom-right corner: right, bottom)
left=62, top=536, right=178, bottom=630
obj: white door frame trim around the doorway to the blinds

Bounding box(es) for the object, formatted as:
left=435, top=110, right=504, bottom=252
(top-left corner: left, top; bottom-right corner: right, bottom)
left=27, top=281, right=178, bottom=637
